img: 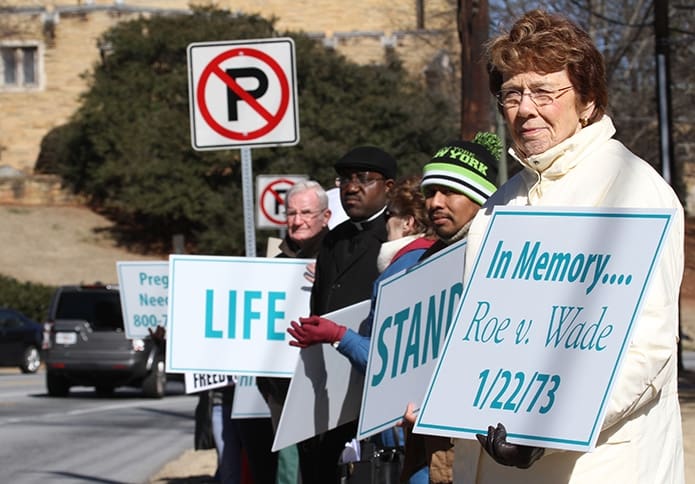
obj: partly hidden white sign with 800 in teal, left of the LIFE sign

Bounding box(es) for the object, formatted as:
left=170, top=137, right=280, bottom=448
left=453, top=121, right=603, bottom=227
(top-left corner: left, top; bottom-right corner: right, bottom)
left=116, top=261, right=169, bottom=339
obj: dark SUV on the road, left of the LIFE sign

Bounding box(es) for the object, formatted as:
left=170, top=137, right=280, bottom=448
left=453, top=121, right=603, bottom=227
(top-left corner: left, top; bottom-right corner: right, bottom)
left=44, top=284, right=166, bottom=398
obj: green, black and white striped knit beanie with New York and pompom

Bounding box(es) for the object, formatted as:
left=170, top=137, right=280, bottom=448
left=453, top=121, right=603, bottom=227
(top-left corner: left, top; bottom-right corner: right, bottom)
left=421, top=132, right=502, bottom=205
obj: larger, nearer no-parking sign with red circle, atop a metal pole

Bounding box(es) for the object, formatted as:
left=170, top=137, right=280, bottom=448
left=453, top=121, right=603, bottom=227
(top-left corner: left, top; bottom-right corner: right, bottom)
left=188, top=38, right=299, bottom=150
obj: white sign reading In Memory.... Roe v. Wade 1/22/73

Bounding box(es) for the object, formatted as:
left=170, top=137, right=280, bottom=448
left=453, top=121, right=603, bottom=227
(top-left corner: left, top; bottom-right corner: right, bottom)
left=415, top=207, right=674, bottom=451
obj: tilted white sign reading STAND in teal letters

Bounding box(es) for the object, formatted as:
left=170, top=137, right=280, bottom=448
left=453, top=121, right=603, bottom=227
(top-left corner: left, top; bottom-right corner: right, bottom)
left=357, top=242, right=466, bottom=439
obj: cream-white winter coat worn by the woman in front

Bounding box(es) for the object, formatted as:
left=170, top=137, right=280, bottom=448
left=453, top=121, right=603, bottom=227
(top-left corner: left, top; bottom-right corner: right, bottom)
left=454, top=116, right=685, bottom=484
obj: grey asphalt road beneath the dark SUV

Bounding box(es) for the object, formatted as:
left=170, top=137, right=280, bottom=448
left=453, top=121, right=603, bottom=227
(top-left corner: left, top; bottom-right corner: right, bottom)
left=0, top=369, right=197, bottom=484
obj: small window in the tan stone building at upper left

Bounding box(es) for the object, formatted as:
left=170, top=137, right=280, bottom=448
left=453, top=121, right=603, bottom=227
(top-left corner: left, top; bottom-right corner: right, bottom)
left=0, top=43, right=41, bottom=91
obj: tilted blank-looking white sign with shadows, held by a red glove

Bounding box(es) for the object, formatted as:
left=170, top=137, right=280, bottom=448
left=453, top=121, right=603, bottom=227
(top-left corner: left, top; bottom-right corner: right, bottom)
left=272, top=300, right=370, bottom=452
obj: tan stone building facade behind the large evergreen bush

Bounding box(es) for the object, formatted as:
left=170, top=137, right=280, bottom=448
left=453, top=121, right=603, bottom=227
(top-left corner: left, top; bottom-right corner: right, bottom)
left=0, top=0, right=458, bottom=183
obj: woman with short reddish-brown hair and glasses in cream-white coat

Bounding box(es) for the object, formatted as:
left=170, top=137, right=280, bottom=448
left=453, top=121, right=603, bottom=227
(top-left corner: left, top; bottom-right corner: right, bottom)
left=454, top=10, right=684, bottom=484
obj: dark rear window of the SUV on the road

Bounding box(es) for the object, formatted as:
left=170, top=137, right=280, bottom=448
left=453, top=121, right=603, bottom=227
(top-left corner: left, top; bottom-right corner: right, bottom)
left=55, top=290, right=123, bottom=331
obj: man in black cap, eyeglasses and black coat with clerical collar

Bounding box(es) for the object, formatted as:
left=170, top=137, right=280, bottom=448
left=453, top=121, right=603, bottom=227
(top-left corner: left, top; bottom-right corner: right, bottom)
left=299, top=146, right=396, bottom=484
